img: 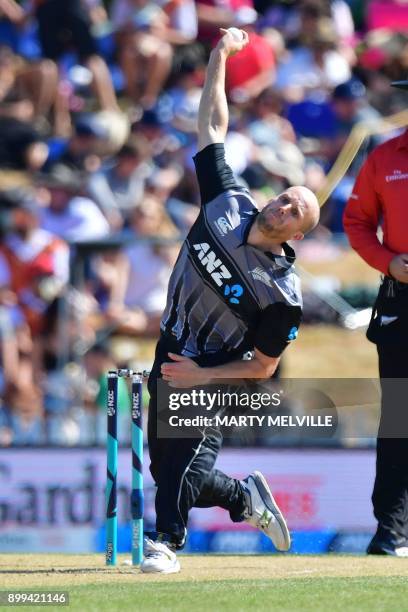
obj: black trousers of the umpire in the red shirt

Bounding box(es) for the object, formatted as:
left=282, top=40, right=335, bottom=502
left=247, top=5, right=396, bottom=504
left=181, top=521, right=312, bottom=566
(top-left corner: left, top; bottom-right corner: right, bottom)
left=367, top=277, right=408, bottom=538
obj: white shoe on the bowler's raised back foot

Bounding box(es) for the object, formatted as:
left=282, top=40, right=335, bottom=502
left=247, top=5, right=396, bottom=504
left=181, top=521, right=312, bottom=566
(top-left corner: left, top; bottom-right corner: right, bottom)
left=241, top=472, right=290, bottom=551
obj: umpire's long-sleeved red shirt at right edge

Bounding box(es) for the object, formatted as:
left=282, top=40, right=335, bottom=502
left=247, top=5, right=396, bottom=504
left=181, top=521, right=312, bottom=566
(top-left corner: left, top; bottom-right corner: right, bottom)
left=343, top=130, right=408, bottom=274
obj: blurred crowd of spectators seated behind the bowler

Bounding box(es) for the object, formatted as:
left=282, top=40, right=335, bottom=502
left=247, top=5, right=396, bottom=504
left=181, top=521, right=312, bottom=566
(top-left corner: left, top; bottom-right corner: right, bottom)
left=0, top=0, right=408, bottom=446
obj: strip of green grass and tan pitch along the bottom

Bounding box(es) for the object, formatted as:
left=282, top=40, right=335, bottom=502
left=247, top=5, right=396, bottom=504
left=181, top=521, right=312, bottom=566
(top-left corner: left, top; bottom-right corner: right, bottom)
left=0, top=555, right=408, bottom=612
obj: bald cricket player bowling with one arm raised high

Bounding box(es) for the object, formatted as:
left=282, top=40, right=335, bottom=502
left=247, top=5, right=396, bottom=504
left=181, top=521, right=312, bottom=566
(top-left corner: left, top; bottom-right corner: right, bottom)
left=141, top=30, right=319, bottom=573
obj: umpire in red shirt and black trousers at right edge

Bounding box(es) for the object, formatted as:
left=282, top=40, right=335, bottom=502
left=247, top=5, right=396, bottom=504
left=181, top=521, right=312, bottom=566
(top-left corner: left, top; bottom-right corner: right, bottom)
left=344, top=80, right=408, bottom=557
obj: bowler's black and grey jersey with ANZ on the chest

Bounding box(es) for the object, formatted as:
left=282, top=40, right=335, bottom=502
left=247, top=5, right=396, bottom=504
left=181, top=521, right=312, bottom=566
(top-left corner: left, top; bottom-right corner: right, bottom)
left=161, top=144, right=302, bottom=365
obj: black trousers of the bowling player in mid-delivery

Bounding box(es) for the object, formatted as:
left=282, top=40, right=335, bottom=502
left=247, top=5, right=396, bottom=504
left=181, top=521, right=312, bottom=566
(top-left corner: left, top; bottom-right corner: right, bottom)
left=148, top=337, right=244, bottom=548
